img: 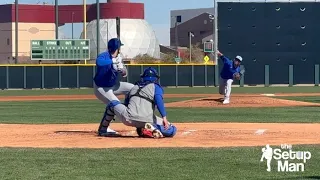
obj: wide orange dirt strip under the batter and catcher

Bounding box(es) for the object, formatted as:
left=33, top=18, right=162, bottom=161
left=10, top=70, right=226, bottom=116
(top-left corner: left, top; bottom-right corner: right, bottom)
left=0, top=123, right=320, bottom=148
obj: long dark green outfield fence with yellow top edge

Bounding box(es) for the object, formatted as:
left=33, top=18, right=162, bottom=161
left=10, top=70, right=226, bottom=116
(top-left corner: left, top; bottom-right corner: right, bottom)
left=0, top=64, right=319, bottom=89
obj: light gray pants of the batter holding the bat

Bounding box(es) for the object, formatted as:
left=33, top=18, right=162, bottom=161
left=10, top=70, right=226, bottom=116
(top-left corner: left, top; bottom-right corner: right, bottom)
left=94, top=82, right=134, bottom=105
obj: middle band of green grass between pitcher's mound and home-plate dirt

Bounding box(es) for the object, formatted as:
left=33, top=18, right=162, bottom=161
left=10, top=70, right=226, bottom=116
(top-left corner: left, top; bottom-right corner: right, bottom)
left=0, top=98, right=320, bottom=124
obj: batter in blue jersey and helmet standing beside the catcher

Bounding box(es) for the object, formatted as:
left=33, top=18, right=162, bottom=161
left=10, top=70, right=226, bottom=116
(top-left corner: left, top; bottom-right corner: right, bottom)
left=93, top=38, right=134, bottom=136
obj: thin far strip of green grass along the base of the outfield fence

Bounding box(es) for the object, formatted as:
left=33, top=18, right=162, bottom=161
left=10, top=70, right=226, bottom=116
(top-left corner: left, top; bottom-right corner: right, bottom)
left=0, top=86, right=320, bottom=96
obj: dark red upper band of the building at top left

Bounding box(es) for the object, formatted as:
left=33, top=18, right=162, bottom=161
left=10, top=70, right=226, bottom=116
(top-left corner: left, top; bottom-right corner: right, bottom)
left=0, top=2, right=144, bottom=24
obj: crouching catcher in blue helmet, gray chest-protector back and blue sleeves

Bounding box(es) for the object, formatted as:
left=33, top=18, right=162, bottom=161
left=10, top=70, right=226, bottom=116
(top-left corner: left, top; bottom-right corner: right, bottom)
left=101, top=67, right=177, bottom=138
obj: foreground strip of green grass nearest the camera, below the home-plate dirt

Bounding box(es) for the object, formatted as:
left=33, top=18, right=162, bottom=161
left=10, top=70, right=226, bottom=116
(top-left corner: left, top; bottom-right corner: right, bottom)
left=0, top=146, right=320, bottom=180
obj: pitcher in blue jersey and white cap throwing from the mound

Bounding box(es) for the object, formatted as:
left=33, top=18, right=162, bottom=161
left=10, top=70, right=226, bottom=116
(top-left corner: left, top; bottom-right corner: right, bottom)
left=217, top=51, right=242, bottom=104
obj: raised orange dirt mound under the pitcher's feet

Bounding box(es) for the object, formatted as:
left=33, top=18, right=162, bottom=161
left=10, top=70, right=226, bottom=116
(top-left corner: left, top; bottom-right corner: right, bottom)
left=166, top=96, right=320, bottom=107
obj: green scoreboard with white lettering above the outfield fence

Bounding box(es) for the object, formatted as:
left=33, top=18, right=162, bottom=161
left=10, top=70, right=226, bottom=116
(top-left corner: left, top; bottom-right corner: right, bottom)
left=30, top=39, right=90, bottom=61
